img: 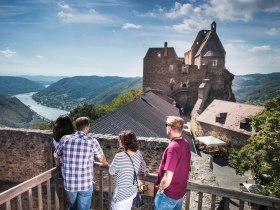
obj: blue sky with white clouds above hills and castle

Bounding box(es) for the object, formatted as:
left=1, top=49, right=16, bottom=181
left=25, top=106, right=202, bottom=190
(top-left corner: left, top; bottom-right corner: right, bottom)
left=0, top=0, right=280, bottom=77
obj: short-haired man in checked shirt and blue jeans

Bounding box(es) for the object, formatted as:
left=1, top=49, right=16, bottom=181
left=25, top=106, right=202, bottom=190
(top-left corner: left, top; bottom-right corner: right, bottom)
left=54, top=117, right=108, bottom=210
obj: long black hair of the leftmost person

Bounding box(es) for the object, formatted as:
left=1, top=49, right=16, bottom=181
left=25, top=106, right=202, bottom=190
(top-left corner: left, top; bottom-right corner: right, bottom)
left=53, top=116, right=75, bottom=142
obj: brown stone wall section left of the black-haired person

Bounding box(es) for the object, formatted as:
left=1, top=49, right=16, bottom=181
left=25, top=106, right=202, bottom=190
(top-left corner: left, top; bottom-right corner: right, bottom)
left=0, top=128, right=52, bottom=182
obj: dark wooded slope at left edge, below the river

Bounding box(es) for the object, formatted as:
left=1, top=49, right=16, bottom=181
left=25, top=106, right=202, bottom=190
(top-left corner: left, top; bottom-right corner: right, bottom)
left=0, top=96, right=33, bottom=128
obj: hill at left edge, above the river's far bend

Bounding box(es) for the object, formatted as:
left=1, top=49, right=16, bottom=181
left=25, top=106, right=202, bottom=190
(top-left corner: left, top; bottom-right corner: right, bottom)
left=0, top=76, right=45, bottom=96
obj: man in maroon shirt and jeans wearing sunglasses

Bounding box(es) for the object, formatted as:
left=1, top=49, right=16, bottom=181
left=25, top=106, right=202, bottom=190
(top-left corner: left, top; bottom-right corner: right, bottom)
left=155, top=116, right=191, bottom=210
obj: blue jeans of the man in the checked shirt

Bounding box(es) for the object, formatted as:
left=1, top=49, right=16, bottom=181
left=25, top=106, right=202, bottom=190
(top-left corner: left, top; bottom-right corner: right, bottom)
left=66, top=184, right=93, bottom=210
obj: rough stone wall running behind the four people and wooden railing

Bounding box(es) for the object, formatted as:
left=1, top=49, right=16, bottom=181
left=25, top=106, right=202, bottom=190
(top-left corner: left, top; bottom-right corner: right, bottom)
left=0, top=128, right=218, bottom=209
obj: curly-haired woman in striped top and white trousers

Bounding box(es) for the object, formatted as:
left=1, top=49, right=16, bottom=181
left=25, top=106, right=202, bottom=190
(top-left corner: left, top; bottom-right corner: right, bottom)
left=109, top=131, right=146, bottom=210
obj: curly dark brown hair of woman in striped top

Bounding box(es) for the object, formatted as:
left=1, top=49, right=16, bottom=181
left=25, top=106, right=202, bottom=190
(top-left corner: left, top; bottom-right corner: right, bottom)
left=119, top=131, right=138, bottom=152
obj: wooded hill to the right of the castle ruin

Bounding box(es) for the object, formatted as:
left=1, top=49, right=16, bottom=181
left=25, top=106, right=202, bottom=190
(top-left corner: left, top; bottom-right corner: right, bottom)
left=232, top=72, right=280, bottom=105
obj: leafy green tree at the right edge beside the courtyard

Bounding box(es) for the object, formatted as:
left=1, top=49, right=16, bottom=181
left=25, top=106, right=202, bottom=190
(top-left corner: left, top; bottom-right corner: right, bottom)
left=230, top=96, right=280, bottom=198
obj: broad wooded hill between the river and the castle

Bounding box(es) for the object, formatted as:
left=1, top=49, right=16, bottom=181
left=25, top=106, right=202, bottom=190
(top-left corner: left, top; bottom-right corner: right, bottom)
left=33, top=76, right=142, bottom=110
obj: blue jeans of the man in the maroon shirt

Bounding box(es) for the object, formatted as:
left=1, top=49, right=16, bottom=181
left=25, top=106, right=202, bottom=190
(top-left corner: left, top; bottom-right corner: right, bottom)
left=155, top=192, right=183, bottom=210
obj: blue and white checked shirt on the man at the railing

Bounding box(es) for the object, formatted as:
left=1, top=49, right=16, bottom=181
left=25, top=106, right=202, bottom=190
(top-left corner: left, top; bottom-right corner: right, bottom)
left=54, top=131, right=104, bottom=192
